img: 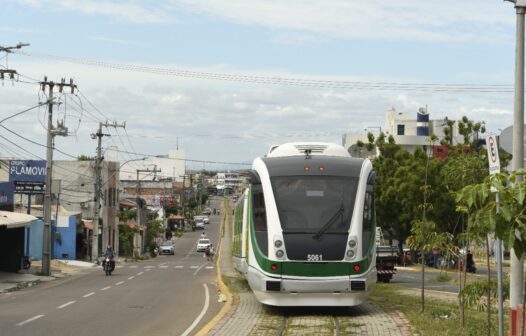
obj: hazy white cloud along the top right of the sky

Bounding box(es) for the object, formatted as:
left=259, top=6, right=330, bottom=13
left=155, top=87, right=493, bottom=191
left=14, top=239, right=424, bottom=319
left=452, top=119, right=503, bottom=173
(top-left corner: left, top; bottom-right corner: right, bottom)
left=172, top=0, right=514, bottom=43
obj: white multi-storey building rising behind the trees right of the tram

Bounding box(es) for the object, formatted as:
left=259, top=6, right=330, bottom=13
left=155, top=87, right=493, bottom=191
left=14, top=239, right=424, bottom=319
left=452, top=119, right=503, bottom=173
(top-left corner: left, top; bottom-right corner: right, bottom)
left=344, top=107, right=474, bottom=157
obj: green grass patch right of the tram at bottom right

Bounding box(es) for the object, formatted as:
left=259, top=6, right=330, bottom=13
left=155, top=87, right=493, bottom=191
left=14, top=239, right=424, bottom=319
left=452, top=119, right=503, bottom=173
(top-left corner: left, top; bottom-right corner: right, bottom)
left=370, top=284, right=508, bottom=336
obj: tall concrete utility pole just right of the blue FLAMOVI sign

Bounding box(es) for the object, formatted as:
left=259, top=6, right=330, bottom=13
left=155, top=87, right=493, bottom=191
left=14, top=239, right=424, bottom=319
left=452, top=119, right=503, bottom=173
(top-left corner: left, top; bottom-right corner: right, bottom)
left=40, top=77, right=73, bottom=276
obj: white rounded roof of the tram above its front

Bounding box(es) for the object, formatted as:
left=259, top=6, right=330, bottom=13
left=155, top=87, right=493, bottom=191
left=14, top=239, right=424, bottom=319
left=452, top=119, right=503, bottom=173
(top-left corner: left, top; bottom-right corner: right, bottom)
left=266, top=142, right=351, bottom=158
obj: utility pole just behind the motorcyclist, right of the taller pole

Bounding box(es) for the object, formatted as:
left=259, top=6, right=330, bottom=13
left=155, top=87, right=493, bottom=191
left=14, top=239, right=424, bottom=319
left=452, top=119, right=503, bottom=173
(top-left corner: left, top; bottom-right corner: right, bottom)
left=91, top=121, right=126, bottom=261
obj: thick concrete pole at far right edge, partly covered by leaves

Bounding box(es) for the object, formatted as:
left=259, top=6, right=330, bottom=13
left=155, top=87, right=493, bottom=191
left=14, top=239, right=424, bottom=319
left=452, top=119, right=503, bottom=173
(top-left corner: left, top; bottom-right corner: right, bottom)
left=510, top=0, right=526, bottom=308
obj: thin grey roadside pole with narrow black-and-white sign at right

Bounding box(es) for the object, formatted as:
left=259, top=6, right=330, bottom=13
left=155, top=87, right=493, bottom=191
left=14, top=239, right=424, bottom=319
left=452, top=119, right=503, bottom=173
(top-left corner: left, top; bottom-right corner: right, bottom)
left=486, top=134, right=504, bottom=336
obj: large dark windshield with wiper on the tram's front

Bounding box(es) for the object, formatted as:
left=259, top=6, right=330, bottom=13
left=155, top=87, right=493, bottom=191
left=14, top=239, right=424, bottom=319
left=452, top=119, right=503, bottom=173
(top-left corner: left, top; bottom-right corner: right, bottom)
left=271, top=176, right=358, bottom=234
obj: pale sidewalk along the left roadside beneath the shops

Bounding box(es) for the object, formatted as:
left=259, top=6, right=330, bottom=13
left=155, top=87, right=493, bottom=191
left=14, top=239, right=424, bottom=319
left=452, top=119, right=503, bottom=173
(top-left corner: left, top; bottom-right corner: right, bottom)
left=0, top=260, right=97, bottom=294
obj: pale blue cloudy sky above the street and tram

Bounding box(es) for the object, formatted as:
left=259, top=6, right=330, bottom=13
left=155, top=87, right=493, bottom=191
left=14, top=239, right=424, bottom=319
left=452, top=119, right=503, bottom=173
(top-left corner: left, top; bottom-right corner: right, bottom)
left=0, top=0, right=516, bottom=170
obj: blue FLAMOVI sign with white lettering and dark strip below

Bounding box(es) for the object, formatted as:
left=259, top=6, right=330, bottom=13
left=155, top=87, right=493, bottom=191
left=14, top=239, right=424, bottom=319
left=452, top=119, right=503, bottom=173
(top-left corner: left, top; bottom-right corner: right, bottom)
left=9, top=160, right=46, bottom=194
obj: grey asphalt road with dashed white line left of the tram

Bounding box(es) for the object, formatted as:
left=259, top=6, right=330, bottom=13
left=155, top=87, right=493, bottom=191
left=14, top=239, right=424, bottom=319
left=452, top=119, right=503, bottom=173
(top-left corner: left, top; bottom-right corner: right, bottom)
left=0, top=197, right=225, bottom=336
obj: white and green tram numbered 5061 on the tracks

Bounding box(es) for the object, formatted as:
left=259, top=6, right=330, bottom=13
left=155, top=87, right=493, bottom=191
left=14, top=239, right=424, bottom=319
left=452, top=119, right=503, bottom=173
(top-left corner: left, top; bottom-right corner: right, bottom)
left=233, top=143, right=376, bottom=306
